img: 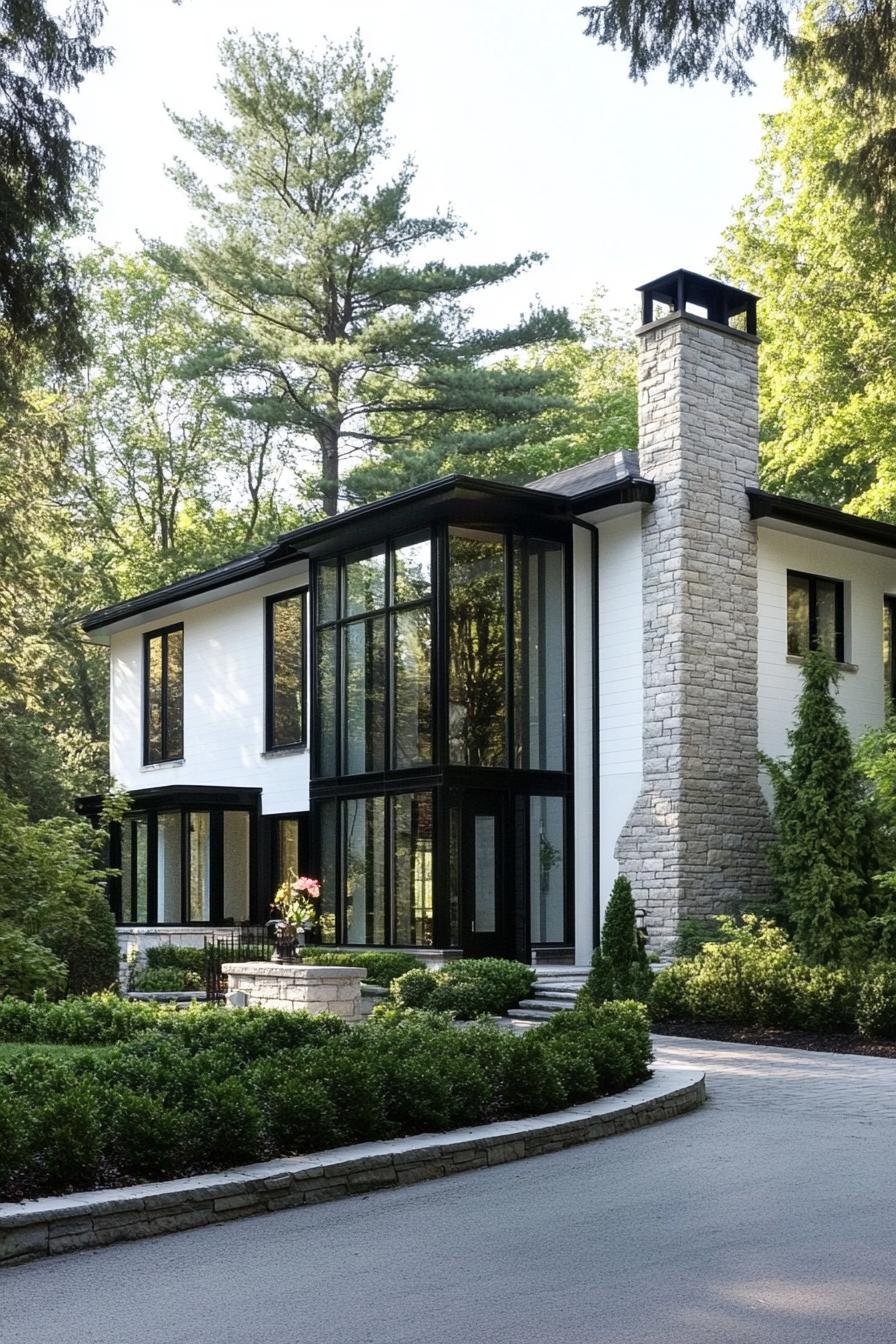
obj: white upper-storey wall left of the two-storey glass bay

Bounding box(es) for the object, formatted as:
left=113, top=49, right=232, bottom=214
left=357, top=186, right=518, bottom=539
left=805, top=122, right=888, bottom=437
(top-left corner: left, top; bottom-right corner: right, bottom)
left=110, top=562, right=309, bottom=813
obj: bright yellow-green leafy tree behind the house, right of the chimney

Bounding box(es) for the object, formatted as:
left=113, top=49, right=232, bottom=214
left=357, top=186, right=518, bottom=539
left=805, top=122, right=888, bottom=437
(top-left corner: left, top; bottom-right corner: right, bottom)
left=720, top=51, right=896, bottom=519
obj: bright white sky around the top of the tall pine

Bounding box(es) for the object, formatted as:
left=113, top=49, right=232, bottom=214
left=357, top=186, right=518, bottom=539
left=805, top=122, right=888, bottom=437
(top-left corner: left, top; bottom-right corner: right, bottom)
left=71, top=0, right=782, bottom=323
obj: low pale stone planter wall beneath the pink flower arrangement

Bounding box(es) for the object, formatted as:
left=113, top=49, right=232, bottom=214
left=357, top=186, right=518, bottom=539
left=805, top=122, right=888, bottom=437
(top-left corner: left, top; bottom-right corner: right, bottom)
left=222, top=961, right=365, bottom=1021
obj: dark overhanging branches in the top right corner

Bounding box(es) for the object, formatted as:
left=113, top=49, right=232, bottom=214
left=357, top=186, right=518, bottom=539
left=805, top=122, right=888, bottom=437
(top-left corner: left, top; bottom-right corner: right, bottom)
left=579, top=0, right=896, bottom=226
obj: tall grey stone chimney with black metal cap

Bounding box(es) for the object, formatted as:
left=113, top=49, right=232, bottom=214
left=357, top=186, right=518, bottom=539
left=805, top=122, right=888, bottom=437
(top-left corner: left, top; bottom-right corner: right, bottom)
left=617, top=270, right=771, bottom=949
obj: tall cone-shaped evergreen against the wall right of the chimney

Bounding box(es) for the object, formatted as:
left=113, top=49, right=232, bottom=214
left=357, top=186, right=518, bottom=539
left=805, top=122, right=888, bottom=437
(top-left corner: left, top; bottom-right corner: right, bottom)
left=763, top=652, right=873, bottom=962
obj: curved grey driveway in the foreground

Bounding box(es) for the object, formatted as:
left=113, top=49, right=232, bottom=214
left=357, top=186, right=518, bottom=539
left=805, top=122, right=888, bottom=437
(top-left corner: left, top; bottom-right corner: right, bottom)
left=0, top=1038, right=896, bottom=1344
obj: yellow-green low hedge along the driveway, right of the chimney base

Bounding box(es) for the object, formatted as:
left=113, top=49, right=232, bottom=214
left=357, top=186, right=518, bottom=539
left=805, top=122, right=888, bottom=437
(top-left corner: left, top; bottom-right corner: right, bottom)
left=649, top=915, right=896, bottom=1040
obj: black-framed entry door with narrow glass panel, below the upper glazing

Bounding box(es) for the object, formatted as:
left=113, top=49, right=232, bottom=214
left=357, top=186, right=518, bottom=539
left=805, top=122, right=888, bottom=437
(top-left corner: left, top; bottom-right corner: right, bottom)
left=461, top=793, right=508, bottom=957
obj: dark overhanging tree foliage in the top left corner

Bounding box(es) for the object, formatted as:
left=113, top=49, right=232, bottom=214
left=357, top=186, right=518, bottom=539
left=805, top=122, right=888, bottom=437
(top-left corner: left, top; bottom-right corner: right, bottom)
left=0, top=0, right=110, bottom=403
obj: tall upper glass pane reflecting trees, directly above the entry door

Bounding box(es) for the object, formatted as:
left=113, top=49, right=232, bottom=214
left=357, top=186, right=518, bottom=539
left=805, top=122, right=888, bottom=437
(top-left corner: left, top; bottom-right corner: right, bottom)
left=449, top=534, right=506, bottom=766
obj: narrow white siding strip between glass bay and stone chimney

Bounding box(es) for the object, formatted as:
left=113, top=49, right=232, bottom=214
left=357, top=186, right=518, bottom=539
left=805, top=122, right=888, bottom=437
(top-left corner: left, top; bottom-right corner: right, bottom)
left=598, top=512, right=643, bottom=911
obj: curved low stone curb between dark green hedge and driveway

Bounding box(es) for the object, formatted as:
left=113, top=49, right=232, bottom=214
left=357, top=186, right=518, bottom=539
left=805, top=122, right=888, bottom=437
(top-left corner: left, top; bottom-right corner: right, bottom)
left=0, top=1067, right=707, bottom=1266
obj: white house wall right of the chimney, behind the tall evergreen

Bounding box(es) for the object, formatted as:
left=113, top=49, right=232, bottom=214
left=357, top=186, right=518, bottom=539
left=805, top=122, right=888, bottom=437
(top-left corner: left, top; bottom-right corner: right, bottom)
left=759, top=524, right=896, bottom=792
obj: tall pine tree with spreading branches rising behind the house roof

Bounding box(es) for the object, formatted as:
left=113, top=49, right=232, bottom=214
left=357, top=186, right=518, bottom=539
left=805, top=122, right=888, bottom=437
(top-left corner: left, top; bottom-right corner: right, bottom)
left=152, top=35, right=571, bottom=513
